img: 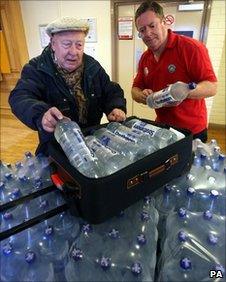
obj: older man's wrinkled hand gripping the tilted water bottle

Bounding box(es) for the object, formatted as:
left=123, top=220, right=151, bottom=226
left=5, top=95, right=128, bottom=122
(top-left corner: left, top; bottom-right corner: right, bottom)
left=42, top=107, right=69, bottom=132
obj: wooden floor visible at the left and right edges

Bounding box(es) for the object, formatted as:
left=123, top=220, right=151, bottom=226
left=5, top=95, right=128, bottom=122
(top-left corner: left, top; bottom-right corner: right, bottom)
left=0, top=111, right=226, bottom=163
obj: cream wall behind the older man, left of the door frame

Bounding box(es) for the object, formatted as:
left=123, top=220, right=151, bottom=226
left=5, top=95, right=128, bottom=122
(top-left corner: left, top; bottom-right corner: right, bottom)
left=20, top=0, right=111, bottom=76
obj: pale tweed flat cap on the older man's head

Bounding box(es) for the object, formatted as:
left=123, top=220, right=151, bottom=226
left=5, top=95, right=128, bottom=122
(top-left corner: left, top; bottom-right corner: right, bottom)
left=46, top=17, right=89, bottom=36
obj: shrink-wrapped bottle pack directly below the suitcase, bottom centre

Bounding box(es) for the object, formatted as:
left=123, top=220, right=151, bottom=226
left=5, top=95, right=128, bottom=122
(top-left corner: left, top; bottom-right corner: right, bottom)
left=65, top=196, right=158, bottom=281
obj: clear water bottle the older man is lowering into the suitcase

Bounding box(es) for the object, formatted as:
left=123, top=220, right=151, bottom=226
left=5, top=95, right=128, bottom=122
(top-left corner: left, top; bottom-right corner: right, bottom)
left=54, top=119, right=104, bottom=178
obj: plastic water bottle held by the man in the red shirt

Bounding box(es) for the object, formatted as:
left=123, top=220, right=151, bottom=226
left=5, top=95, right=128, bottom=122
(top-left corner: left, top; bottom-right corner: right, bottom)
left=146, top=81, right=196, bottom=109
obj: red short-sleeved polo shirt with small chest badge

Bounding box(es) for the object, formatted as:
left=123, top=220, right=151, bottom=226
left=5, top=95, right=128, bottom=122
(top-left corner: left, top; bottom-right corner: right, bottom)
left=133, top=30, right=217, bottom=134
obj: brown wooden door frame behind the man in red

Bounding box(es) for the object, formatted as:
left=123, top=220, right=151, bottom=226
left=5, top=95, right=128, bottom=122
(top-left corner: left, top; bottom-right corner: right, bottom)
left=111, top=0, right=213, bottom=81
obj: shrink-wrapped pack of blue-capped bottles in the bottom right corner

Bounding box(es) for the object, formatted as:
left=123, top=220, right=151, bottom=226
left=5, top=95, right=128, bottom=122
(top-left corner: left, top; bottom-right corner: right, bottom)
left=158, top=208, right=226, bottom=281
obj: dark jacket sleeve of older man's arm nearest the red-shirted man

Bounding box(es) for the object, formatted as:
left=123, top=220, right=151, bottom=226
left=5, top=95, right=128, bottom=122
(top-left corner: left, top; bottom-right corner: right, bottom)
left=99, top=67, right=126, bottom=115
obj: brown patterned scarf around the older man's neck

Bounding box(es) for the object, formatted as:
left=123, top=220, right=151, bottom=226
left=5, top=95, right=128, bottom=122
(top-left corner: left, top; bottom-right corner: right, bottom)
left=52, top=51, right=87, bottom=124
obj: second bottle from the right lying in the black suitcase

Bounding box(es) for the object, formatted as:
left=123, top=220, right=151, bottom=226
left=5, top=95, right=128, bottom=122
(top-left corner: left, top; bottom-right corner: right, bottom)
left=107, top=122, right=159, bottom=154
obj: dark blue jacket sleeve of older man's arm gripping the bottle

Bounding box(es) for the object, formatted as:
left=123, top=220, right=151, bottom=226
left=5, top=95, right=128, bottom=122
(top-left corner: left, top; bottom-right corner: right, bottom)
left=9, top=64, right=50, bottom=131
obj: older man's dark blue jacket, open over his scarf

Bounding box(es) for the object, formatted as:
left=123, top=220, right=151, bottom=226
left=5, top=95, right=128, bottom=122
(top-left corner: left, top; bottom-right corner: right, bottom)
left=9, top=46, right=126, bottom=155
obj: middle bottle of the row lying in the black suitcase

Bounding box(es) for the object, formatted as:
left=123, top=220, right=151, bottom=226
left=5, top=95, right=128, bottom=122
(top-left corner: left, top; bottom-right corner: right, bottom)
left=93, top=128, right=147, bottom=162
